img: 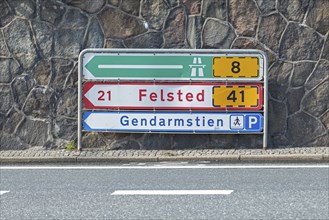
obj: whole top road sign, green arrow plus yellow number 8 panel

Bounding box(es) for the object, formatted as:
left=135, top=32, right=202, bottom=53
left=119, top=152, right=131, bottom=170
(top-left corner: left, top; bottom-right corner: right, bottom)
left=80, top=50, right=265, bottom=81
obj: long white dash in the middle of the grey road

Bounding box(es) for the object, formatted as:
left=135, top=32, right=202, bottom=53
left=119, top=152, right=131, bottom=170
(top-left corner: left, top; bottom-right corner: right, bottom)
left=111, top=190, right=233, bottom=195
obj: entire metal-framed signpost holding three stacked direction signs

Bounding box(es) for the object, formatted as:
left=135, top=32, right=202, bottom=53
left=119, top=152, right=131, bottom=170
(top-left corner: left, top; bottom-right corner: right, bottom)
left=78, top=49, right=268, bottom=149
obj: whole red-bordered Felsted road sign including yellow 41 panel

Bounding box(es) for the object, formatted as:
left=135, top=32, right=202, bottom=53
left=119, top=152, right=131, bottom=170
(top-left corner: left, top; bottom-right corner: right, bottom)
left=83, top=82, right=262, bottom=110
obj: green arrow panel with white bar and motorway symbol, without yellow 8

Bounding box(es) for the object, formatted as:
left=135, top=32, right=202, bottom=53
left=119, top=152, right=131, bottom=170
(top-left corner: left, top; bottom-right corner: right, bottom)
left=85, top=54, right=213, bottom=79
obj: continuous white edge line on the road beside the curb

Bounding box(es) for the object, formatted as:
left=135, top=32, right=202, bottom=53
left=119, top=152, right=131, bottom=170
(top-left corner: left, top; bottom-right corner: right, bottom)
left=0, top=164, right=329, bottom=170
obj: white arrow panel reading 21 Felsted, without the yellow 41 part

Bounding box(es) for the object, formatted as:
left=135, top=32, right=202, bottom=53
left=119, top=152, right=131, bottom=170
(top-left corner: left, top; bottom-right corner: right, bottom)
left=84, top=83, right=209, bottom=108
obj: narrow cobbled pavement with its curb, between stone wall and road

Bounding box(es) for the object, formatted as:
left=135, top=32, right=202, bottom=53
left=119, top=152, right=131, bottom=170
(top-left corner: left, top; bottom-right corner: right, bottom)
left=0, top=147, right=329, bottom=164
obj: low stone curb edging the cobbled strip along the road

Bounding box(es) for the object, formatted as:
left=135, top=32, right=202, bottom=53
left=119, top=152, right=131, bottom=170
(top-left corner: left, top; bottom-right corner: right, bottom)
left=0, top=154, right=329, bottom=164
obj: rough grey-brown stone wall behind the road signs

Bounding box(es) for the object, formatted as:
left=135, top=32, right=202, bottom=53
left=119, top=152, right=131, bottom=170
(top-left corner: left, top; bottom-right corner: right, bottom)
left=0, top=0, right=329, bottom=149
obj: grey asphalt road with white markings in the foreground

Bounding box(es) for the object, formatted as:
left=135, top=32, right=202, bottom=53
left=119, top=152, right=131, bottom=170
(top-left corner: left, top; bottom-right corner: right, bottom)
left=0, top=164, right=329, bottom=220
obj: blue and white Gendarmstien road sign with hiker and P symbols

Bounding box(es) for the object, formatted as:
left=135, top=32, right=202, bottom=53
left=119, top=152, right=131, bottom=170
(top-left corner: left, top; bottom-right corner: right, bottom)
left=83, top=111, right=263, bottom=133
